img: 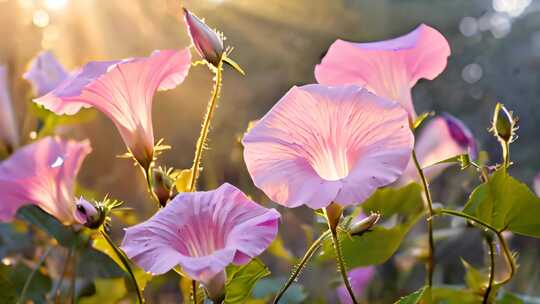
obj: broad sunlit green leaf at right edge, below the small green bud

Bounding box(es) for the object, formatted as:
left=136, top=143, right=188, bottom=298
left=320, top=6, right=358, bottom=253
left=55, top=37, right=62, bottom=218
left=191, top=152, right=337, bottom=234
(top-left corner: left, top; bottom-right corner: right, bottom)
left=463, top=170, right=540, bottom=238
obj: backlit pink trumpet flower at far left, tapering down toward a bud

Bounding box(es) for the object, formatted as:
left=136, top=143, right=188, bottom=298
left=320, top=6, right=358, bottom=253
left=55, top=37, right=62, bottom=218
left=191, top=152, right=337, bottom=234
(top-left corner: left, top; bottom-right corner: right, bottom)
left=0, top=137, right=91, bottom=225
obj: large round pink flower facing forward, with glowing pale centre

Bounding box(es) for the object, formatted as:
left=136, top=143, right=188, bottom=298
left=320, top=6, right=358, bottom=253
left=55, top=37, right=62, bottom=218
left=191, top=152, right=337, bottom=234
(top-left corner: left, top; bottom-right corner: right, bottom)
left=242, top=84, right=414, bottom=209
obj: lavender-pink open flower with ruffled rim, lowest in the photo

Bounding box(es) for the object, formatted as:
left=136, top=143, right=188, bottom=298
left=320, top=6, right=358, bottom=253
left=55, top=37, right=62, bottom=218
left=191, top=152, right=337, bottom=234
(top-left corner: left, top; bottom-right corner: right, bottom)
left=121, top=184, right=279, bottom=298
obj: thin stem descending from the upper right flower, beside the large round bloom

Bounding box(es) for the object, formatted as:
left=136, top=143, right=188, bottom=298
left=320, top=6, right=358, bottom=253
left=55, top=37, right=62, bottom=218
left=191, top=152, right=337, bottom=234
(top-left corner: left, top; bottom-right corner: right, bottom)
left=412, top=149, right=435, bottom=287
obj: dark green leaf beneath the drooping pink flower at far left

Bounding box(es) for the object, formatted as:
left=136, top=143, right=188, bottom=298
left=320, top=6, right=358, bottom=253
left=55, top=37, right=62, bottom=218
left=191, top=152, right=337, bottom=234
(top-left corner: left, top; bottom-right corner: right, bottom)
left=17, top=205, right=79, bottom=247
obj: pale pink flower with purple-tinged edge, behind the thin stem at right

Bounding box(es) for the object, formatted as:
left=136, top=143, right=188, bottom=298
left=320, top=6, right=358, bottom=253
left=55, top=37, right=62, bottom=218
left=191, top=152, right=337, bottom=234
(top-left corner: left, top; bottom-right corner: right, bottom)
left=398, top=113, right=478, bottom=185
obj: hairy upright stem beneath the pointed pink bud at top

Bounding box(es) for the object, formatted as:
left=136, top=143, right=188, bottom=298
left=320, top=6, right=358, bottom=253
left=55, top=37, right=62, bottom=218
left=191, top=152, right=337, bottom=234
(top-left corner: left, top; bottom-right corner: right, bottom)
left=188, top=61, right=223, bottom=192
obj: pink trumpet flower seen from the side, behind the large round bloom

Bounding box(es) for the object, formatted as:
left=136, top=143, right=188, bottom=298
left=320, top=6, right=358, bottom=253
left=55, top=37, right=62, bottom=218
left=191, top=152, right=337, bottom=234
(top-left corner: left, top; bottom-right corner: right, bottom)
left=315, top=24, right=450, bottom=120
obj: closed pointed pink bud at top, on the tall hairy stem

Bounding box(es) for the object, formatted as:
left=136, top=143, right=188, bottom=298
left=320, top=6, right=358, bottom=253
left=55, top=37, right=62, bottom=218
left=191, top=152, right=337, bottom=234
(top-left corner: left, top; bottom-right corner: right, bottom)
left=184, top=8, right=224, bottom=66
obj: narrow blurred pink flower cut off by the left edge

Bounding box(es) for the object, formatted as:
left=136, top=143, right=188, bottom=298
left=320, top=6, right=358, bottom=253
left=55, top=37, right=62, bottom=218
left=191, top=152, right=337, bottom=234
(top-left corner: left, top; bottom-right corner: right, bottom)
left=0, top=65, right=19, bottom=150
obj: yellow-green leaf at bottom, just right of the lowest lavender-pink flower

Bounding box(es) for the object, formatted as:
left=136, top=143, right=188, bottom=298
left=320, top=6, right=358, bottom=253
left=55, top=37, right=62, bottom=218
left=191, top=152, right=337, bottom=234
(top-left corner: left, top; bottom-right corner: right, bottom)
left=224, top=259, right=270, bottom=304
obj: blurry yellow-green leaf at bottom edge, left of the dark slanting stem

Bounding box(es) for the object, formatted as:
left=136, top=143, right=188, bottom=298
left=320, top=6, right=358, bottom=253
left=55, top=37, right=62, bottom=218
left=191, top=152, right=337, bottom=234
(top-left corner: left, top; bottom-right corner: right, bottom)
left=78, top=278, right=127, bottom=304
